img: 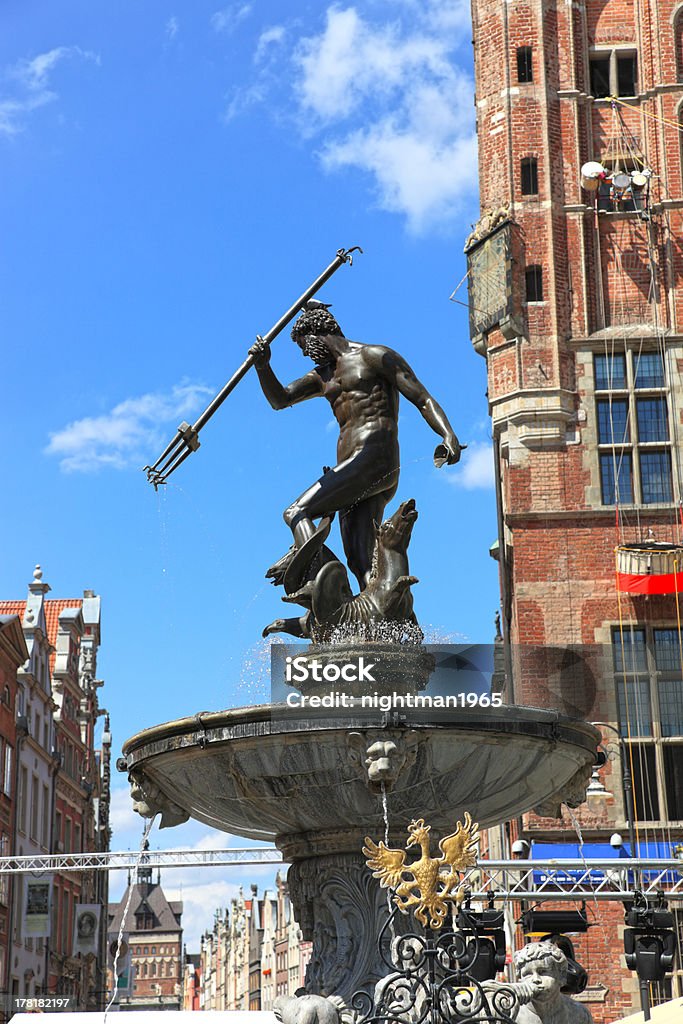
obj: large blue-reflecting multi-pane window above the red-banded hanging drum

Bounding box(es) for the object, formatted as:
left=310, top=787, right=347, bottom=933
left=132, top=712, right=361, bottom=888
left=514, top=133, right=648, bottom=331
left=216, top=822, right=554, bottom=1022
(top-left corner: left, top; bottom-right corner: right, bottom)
left=594, top=351, right=674, bottom=505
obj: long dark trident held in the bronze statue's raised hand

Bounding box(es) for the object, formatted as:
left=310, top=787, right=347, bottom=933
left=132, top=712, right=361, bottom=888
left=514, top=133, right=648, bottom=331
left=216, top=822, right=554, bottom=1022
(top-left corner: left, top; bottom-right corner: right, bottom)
left=144, top=246, right=362, bottom=490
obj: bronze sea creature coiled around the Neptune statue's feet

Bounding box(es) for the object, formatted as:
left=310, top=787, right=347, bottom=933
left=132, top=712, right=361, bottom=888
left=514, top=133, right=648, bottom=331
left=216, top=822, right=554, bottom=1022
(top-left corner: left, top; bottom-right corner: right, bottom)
left=263, top=499, right=423, bottom=643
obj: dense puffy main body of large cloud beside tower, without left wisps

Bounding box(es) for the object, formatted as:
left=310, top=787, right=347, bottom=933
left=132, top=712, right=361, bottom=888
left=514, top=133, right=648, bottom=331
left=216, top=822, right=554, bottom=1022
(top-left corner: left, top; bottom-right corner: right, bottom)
left=293, top=2, right=477, bottom=231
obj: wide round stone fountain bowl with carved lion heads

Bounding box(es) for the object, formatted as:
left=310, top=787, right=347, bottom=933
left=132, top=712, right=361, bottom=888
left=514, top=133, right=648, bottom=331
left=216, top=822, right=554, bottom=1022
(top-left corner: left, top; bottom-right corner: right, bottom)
left=120, top=705, right=600, bottom=860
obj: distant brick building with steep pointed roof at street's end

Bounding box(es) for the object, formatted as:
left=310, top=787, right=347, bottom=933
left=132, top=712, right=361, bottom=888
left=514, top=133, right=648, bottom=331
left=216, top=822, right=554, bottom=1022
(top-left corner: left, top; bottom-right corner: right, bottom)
left=108, top=864, right=183, bottom=1010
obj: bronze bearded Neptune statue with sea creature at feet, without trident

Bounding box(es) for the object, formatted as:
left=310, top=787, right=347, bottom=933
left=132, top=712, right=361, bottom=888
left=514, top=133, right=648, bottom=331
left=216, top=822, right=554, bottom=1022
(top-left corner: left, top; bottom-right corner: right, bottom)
left=249, top=300, right=463, bottom=639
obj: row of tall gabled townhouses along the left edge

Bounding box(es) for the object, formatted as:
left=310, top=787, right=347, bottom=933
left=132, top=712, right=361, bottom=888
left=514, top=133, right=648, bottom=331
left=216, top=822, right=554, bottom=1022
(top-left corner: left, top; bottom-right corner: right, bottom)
left=0, top=566, right=111, bottom=1010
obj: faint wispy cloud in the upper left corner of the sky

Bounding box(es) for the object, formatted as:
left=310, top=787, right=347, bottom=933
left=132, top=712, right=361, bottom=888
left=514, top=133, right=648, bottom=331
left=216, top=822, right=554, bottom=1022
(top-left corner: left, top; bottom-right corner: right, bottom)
left=0, top=46, right=99, bottom=137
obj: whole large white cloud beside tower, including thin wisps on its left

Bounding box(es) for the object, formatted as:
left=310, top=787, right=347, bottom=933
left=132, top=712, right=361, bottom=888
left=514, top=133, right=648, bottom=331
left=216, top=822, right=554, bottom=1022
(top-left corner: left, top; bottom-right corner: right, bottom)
left=212, top=0, right=477, bottom=232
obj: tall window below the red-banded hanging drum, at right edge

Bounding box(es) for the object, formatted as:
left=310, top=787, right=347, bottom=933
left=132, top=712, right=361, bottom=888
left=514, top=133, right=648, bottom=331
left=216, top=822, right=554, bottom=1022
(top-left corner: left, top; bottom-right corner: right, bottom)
left=612, top=627, right=683, bottom=821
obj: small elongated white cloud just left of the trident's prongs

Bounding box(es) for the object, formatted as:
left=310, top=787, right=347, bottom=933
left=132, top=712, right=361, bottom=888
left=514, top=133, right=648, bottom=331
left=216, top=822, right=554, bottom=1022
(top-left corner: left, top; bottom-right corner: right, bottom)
left=45, top=383, right=212, bottom=473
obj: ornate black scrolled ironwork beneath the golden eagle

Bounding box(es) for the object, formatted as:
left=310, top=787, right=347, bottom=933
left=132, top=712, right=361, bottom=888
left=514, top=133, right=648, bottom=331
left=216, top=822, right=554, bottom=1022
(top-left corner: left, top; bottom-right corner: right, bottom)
left=350, top=908, right=519, bottom=1024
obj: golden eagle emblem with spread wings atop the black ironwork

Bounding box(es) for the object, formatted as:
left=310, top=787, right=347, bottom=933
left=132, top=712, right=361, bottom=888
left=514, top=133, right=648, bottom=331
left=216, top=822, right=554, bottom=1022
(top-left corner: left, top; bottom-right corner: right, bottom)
left=362, top=811, right=479, bottom=929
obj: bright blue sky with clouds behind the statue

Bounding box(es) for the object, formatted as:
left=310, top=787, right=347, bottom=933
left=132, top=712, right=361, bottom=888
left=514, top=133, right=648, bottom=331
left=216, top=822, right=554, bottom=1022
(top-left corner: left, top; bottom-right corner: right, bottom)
left=0, top=0, right=497, bottom=934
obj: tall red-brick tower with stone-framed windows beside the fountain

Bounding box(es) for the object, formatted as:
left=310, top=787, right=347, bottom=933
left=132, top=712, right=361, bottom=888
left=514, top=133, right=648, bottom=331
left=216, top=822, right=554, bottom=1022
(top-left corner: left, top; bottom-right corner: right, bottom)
left=466, top=0, right=683, bottom=1022
